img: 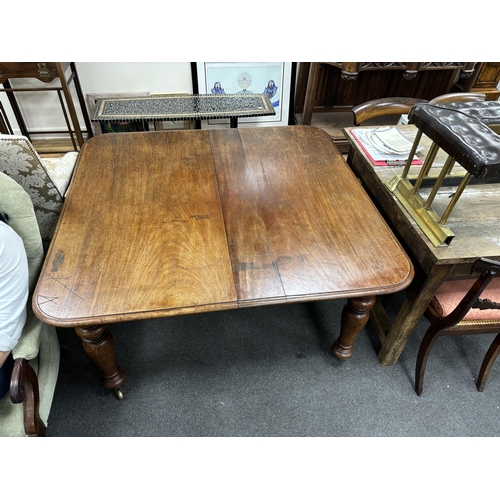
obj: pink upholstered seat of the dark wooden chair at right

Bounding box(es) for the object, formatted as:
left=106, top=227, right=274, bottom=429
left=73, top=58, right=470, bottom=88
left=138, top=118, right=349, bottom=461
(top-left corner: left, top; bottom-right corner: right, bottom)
left=430, top=278, right=500, bottom=322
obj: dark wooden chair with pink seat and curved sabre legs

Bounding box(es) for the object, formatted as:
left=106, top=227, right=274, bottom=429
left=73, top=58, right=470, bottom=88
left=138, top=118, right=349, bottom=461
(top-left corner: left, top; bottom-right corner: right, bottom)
left=415, top=259, right=500, bottom=396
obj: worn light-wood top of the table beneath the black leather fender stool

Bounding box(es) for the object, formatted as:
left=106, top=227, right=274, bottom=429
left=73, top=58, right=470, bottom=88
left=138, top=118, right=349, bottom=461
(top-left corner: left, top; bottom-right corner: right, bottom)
left=345, top=125, right=500, bottom=266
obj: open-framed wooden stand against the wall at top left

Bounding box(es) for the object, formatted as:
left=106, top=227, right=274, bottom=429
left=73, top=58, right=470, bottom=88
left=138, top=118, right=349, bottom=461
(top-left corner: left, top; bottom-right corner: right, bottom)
left=0, top=62, right=93, bottom=152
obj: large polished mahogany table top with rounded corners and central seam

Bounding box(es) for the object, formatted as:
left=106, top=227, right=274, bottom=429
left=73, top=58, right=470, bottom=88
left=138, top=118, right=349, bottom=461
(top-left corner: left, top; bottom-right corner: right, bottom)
left=33, top=126, right=413, bottom=326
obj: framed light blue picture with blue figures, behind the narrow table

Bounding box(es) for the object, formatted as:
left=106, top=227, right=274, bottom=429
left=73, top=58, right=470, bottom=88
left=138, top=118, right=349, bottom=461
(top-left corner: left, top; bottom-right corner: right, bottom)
left=193, top=62, right=292, bottom=128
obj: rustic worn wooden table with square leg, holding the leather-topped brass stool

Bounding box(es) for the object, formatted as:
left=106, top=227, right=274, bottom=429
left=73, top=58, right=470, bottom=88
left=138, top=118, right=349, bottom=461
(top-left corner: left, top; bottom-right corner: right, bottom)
left=345, top=125, right=500, bottom=365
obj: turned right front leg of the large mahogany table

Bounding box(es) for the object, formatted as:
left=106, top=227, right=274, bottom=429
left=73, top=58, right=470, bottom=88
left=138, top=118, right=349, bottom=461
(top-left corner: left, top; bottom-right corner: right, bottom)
left=332, top=297, right=376, bottom=361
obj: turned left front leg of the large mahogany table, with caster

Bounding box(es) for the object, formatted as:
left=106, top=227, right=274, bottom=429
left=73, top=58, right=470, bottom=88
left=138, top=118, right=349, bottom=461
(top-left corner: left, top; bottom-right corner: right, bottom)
left=75, top=325, right=125, bottom=399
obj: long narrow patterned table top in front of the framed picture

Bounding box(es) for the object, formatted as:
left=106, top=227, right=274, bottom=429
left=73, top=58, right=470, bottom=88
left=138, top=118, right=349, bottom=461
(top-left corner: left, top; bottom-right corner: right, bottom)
left=91, top=94, right=276, bottom=121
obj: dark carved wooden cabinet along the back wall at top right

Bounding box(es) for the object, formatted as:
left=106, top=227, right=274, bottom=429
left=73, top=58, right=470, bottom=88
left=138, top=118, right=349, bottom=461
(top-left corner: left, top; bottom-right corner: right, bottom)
left=295, top=62, right=500, bottom=152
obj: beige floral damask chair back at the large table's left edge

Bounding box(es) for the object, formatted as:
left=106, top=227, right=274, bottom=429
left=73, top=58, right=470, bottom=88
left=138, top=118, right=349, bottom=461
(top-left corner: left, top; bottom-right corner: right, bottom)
left=0, top=135, right=67, bottom=240
